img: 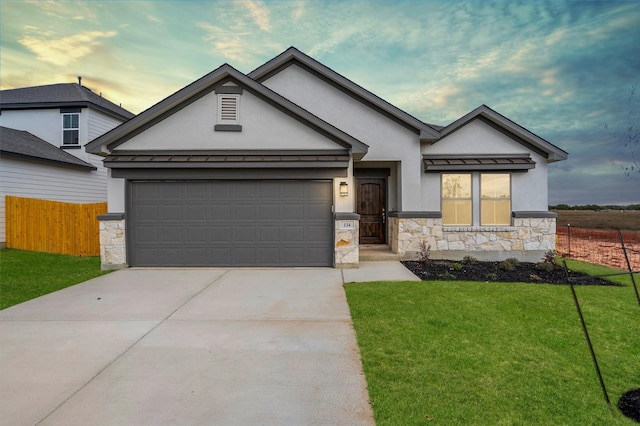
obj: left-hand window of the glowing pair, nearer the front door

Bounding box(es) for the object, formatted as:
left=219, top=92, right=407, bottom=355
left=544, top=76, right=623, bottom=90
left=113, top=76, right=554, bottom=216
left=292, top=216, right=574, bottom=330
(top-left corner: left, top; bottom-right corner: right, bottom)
left=442, top=173, right=472, bottom=226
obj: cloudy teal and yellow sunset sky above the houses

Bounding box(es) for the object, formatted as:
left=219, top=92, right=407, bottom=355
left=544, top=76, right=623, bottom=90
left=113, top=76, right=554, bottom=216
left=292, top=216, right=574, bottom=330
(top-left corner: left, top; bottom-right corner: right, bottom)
left=0, top=0, right=640, bottom=204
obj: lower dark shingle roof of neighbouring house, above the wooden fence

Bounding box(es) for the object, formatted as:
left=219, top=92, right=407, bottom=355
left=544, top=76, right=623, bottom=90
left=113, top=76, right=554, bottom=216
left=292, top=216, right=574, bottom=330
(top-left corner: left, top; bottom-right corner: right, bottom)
left=0, top=126, right=96, bottom=170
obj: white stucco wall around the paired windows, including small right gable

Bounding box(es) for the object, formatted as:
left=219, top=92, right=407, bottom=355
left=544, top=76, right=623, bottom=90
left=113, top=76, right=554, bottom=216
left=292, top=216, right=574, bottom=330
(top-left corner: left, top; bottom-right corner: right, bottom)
left=422, top=120, right=548, bottom=212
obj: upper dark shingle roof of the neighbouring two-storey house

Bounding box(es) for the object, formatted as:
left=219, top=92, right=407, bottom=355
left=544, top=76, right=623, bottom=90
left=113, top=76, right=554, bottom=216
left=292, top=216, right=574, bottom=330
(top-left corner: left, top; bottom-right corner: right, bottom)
left=0, top=83, right=135, bottom=120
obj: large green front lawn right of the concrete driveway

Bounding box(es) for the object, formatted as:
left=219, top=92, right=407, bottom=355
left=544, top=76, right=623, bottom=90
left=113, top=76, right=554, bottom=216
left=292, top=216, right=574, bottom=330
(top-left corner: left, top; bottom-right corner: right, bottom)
left=345, top=262, right=640, bottom=425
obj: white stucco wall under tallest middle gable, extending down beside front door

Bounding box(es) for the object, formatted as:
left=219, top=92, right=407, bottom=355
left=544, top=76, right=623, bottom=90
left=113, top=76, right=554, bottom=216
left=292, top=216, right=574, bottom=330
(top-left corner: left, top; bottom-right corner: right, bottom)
left=263, top=65, right=421, bottom=211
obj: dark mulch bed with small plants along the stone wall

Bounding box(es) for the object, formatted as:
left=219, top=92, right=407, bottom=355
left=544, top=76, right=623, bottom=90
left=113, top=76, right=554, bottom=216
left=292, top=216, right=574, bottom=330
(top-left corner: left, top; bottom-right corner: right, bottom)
left=402, top=260, right=619, bottom=286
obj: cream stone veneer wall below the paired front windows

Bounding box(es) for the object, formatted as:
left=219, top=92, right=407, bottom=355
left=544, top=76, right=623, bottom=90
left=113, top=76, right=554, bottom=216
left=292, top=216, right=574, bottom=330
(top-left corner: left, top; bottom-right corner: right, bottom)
left=389, top=217, right=556, bottom=262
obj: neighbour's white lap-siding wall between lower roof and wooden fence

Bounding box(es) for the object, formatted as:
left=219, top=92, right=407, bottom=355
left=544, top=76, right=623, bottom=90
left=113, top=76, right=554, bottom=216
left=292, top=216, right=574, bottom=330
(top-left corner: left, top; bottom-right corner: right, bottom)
left=0, top=156, right=107, bottom=243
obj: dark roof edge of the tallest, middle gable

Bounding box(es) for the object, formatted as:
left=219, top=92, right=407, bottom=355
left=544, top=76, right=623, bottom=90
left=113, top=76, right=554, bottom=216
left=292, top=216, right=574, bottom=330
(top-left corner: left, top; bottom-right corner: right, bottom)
left=248, top=47, right=438, bottom=141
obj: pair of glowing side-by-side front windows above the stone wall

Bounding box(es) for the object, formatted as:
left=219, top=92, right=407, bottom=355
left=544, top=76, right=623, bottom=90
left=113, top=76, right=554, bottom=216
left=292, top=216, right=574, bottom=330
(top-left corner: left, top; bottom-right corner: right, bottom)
left=442, top=172, right=511, bottom=226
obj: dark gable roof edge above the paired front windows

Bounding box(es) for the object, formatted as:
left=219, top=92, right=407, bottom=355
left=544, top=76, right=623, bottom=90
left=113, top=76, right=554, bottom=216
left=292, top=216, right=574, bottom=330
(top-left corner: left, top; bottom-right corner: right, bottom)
left=434, top=105, right=569, bottom=163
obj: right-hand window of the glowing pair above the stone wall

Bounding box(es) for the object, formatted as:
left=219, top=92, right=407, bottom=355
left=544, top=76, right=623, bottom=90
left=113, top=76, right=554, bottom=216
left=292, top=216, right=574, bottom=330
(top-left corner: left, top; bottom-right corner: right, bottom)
left=480, top=173, right=511, bottom=225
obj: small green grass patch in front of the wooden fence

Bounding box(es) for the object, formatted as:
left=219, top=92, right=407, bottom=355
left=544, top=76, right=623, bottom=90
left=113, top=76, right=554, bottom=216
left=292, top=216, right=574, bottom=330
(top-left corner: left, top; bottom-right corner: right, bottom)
left=0, top=249, right=107, bottom=309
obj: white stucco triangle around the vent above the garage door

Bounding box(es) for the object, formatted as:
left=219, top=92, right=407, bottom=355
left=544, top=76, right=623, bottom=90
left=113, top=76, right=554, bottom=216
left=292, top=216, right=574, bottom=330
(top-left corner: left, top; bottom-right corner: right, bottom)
left=118, top=91, right=343, bottom=150
